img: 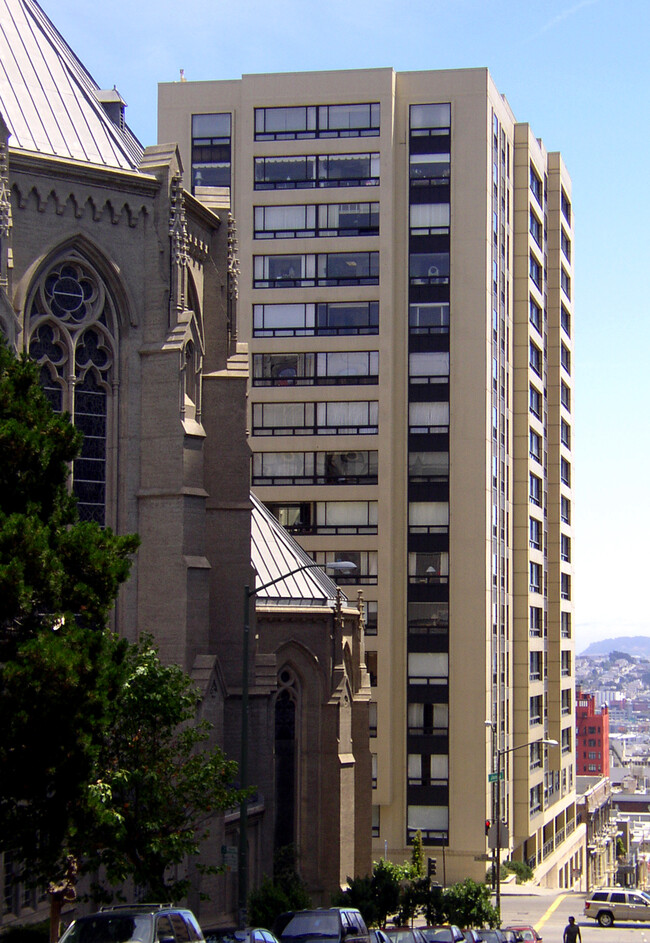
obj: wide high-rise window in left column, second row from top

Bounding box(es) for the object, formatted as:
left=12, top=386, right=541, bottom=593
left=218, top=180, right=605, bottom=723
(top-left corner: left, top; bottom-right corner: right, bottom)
left=255, top=153, right=379, bottom=190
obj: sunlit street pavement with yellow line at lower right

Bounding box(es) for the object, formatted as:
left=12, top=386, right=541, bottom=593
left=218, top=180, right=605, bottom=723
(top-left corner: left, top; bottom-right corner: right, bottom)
left=501, top=890, right=650, bottom=943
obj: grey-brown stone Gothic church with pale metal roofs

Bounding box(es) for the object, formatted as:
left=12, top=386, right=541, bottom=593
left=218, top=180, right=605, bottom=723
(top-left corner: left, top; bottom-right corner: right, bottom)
left=0, top=0, right=371, bottom=926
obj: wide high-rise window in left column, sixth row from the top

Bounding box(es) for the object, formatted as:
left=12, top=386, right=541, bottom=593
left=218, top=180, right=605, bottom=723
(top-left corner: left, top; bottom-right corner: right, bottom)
left=253, top=350, right=379, bottom=386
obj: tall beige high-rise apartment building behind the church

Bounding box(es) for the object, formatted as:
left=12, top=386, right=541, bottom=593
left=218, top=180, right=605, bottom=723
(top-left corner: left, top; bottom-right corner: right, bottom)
left=159, top=69, right=582, bottom=886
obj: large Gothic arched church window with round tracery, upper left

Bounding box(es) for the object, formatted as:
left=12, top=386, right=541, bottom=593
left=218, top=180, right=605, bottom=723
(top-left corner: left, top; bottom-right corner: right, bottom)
left=27, top=253, right=117, bottom=526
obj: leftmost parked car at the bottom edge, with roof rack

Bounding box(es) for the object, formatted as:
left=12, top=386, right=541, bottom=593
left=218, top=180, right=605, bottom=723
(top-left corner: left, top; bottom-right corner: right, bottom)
left=59, top=904, right=203, bottom=943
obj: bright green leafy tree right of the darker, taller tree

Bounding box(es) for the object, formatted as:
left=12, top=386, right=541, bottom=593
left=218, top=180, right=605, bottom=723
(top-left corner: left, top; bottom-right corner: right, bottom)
left=85, top=637, right=247, bottom=900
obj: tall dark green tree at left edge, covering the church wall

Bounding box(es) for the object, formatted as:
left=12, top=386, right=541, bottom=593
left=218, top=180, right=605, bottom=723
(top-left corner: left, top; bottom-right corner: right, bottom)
left=0, top=343, right=138, bottom=896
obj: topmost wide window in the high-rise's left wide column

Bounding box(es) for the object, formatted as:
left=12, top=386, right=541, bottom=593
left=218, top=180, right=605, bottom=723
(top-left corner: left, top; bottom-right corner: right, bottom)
left=255, top=102, right=380, bottom=141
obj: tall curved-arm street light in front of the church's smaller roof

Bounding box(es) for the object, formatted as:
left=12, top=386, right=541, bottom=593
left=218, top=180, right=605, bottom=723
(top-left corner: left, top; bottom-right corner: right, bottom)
left=237, top=560, right=357, bottom=930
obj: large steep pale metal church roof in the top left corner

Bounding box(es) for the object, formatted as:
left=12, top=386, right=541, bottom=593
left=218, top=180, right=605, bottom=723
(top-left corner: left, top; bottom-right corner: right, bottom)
left=0, top=0, right=142, bottom=170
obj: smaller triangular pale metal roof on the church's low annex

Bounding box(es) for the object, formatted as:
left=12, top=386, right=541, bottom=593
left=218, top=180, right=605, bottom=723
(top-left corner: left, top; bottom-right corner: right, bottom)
left=251, top=494, right=347, bottom=606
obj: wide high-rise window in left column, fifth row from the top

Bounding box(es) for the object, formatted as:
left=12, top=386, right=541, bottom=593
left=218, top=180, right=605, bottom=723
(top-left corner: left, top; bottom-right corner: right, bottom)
left=253, top=301, right=379, bottom=337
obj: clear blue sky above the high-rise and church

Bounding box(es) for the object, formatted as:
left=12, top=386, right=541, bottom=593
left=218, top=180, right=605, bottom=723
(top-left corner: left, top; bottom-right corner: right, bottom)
left=41, top=0, right=650, bottom=651
